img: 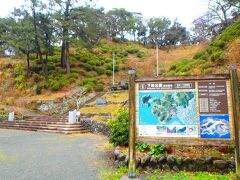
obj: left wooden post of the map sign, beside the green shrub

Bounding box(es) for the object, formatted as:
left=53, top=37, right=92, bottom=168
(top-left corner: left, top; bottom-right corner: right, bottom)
left=128, top=70, right=136, bottom=178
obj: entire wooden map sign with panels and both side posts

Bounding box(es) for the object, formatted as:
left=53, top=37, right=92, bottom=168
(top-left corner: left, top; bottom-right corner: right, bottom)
left=129, top=71, right=240, bottom=178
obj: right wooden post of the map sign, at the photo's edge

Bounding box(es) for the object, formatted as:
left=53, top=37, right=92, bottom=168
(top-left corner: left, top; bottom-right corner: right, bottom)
left=229, top=66, right=240, bottom=177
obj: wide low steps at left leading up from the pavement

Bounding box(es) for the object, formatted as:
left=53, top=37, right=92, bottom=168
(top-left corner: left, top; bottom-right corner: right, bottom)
left=0, top=116, right=89, bottom=134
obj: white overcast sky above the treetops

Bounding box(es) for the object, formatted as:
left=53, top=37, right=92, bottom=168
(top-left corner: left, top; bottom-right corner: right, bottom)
left=0, top=0, right=208, bottom=28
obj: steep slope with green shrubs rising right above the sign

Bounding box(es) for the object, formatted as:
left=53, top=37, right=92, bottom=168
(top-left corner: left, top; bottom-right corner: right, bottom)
left=165, top=20, right=240, bottom=75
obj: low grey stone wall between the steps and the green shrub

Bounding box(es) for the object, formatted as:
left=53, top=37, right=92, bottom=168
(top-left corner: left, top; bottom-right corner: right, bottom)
left=80, top=119, right=109, bottom=136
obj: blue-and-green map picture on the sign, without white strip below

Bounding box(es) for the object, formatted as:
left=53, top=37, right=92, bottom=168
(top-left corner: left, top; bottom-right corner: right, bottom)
left=139, top=91, right=197, bottom=125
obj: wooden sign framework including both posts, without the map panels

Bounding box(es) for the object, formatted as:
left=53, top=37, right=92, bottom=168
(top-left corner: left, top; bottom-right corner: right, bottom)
left=129, top=71, right=240, bottom=178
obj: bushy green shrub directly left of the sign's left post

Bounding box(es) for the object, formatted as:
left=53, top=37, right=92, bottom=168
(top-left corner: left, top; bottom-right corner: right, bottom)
left=108, top=107, right=129, bottom=146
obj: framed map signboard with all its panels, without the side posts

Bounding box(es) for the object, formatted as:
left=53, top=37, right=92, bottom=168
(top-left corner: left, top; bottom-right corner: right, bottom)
left=136, top=76, right=233, bottom=146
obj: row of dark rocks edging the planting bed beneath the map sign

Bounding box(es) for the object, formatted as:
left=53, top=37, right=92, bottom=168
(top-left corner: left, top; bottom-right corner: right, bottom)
left=114, top=147, right=235, bottom=173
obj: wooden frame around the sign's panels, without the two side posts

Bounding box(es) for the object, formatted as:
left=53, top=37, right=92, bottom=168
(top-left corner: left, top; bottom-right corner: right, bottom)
left=135, top=74, right=234, bottom=145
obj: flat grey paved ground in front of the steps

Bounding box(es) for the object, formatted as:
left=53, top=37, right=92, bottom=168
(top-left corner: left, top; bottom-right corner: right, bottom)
left=0, top=130, right=107, bottom=180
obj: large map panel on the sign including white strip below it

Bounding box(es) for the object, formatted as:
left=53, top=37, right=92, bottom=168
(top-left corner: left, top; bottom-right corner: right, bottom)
left=138, top=91, right=198, bottom=137
